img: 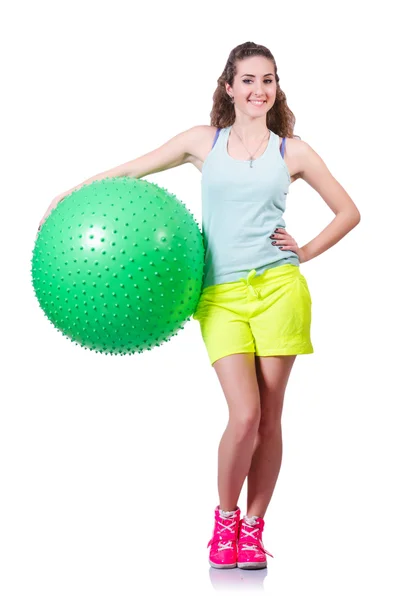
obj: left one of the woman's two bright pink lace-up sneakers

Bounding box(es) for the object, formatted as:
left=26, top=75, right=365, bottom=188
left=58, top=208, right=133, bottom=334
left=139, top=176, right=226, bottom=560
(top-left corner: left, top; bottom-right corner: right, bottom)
left=207, top=505, right=240, bottom=569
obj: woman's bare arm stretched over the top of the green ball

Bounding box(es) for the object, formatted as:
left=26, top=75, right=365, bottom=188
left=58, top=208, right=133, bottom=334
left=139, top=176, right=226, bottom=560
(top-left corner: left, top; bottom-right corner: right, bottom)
left=39, top=125, right=203, bottom=229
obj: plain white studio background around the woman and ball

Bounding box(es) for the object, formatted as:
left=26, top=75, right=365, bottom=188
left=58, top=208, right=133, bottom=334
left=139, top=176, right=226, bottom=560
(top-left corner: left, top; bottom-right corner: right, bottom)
left=0, top=0, right=397, bottom=600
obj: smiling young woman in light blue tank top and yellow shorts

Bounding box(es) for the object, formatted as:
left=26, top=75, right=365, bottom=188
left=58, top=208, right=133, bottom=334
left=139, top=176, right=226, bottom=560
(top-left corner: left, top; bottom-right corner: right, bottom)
left=40, top=42, right=360, bottom=568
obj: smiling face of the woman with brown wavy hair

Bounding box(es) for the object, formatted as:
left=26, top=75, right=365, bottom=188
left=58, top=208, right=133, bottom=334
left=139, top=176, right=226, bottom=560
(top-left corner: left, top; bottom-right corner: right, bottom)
left=225, top=56, right=277, bottom=117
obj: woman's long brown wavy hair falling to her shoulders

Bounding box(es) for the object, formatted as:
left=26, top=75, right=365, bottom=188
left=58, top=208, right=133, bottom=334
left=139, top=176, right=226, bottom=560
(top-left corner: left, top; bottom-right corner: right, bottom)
left=210, top=42, right=300, bottom=139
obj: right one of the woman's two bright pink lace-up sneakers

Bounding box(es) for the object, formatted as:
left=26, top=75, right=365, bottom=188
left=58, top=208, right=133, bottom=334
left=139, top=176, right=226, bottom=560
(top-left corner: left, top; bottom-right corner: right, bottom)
left=237, top=516, right=274, bottom=569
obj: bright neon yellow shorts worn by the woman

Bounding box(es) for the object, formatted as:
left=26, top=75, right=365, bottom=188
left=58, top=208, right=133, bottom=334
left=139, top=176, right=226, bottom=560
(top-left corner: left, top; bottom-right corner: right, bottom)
left=193, top=264, right=314, bottom=365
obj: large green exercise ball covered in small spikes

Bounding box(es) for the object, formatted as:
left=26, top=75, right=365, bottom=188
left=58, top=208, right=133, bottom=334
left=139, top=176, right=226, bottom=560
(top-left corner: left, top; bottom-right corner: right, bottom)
left=31, top=177, right=204, bottom=355
